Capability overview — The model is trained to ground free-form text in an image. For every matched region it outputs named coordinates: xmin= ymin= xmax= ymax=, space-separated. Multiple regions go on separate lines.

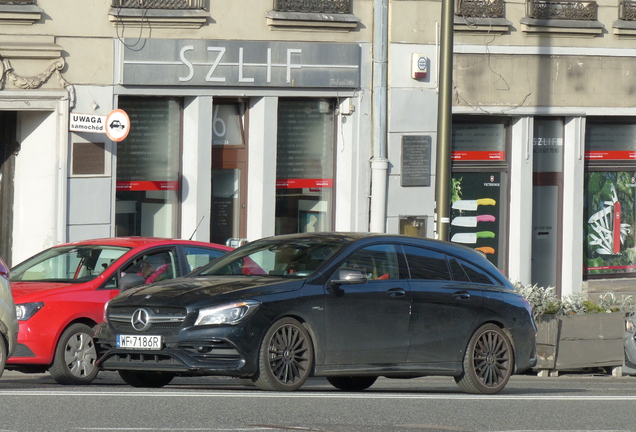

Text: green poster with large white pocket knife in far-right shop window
xmin=584 ymin=171 xmax=636 ymax=275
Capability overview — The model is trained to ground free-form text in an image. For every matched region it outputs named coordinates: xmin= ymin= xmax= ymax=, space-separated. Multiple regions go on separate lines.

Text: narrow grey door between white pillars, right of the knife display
xmin=532 ymin=118 xmax=563 ymax=294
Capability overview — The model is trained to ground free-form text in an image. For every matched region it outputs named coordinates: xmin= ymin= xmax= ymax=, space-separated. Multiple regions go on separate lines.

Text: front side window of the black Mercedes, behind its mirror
xmin=336 ymin=244 xmax=400 ymax=280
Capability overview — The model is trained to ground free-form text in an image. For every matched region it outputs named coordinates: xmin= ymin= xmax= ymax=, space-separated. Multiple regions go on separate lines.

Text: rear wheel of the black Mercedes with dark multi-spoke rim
xmin=455 ymin=324 xmax=514 ymax=394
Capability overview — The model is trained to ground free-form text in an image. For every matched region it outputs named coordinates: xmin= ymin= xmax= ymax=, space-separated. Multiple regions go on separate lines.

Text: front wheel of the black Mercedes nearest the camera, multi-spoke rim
xmin=254 ymin=318 xmax=314 ymax=391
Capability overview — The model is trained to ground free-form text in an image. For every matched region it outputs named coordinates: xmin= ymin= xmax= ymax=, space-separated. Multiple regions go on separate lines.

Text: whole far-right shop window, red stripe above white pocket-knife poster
xmin=583 ymin=118 xmax=636 ymax=278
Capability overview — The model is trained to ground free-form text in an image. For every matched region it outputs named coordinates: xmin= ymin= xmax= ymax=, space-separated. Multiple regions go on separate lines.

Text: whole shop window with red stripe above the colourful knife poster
xmin=449 ymin=118 xmax=508 ymax=270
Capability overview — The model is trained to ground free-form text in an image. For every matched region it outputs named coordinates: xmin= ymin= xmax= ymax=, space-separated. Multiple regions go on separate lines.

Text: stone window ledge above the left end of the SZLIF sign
xmin=109 ymin=8 xmax=210 ymax=29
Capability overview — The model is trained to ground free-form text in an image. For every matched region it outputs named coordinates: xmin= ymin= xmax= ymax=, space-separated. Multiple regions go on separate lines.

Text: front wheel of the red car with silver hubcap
xmin=49 ymin=323 xmax=99 ymax=385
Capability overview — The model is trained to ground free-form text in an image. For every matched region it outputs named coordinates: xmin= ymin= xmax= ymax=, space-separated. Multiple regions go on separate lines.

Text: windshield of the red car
xmin=11 ymin=245 xmax=130 ymax=283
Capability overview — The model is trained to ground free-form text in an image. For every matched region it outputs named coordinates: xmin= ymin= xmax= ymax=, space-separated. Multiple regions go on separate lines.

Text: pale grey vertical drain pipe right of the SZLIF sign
xmin=369 ymin=0 xmax=389 ymax=232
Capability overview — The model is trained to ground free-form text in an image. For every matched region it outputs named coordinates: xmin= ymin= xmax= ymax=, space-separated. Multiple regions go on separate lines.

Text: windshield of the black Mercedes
xmin=198 ymin=238 xmax=345 ymax=277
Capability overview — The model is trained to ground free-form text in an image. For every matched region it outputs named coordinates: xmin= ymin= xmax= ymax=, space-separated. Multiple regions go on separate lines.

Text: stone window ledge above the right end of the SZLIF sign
xmin=266 ymin=11 xmax=360 ymax=31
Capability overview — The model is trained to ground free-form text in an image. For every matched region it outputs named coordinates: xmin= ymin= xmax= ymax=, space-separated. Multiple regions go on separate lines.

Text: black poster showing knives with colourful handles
xmin=450 ymin=172 xmax=501 ymax=265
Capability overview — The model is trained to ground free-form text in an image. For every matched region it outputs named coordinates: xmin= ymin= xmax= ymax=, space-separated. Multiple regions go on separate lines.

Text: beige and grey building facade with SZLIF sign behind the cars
xmin=0 ymin=0 xmax=636 ymax=295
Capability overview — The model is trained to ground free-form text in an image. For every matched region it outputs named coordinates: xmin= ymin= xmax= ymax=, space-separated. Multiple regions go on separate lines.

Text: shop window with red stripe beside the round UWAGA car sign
xmin=115 ymin=97 xmax=181 ymax=237
